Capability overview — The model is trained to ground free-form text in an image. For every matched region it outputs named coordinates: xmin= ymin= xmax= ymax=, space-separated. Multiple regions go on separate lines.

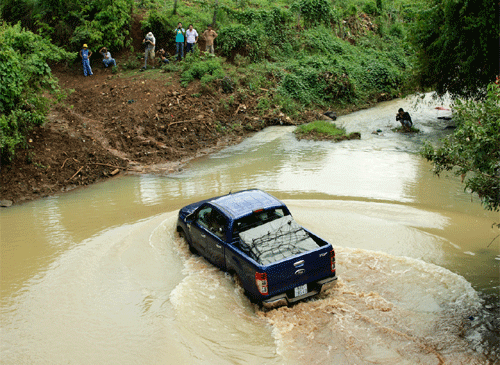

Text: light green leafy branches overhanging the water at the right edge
xmin=422 ymin=78 xmax=500 ymax=211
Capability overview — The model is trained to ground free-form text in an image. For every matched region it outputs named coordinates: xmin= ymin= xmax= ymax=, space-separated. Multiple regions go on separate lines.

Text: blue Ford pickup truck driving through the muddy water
xmin=177 ymin=189 xmax=337 ymax=308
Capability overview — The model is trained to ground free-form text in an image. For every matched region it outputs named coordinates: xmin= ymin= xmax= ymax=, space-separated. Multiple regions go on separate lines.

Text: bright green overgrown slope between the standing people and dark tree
xmin=142 ymin=0 xmax=419 ymax=115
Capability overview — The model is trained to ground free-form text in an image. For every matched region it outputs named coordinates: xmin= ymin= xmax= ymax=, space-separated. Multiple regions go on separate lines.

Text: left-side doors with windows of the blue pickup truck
xmin=191 ymin=206 xmax=228 ymax=269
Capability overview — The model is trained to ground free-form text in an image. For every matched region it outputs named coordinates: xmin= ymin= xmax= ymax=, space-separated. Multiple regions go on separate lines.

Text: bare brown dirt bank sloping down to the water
xmin=0 ymin=65 xmax=317 ymax=204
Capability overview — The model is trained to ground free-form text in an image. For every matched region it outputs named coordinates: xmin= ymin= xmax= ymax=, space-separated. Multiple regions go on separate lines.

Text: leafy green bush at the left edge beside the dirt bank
xmin=0 ymin=23 xmax=76 ymax=162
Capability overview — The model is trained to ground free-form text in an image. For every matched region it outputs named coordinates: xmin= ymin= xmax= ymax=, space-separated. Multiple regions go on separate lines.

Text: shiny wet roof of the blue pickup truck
xmin=210 ymin=189 xmax=283 ymax=219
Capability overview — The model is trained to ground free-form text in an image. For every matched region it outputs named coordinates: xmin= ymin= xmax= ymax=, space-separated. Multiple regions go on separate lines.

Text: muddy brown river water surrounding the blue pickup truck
xmin=0 ymin=94 xmax=500 ymax=364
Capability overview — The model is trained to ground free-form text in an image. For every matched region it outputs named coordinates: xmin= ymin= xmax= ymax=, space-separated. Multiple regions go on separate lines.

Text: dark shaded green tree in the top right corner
xmin=413 ymin=0 xmax=500 ymax=99
